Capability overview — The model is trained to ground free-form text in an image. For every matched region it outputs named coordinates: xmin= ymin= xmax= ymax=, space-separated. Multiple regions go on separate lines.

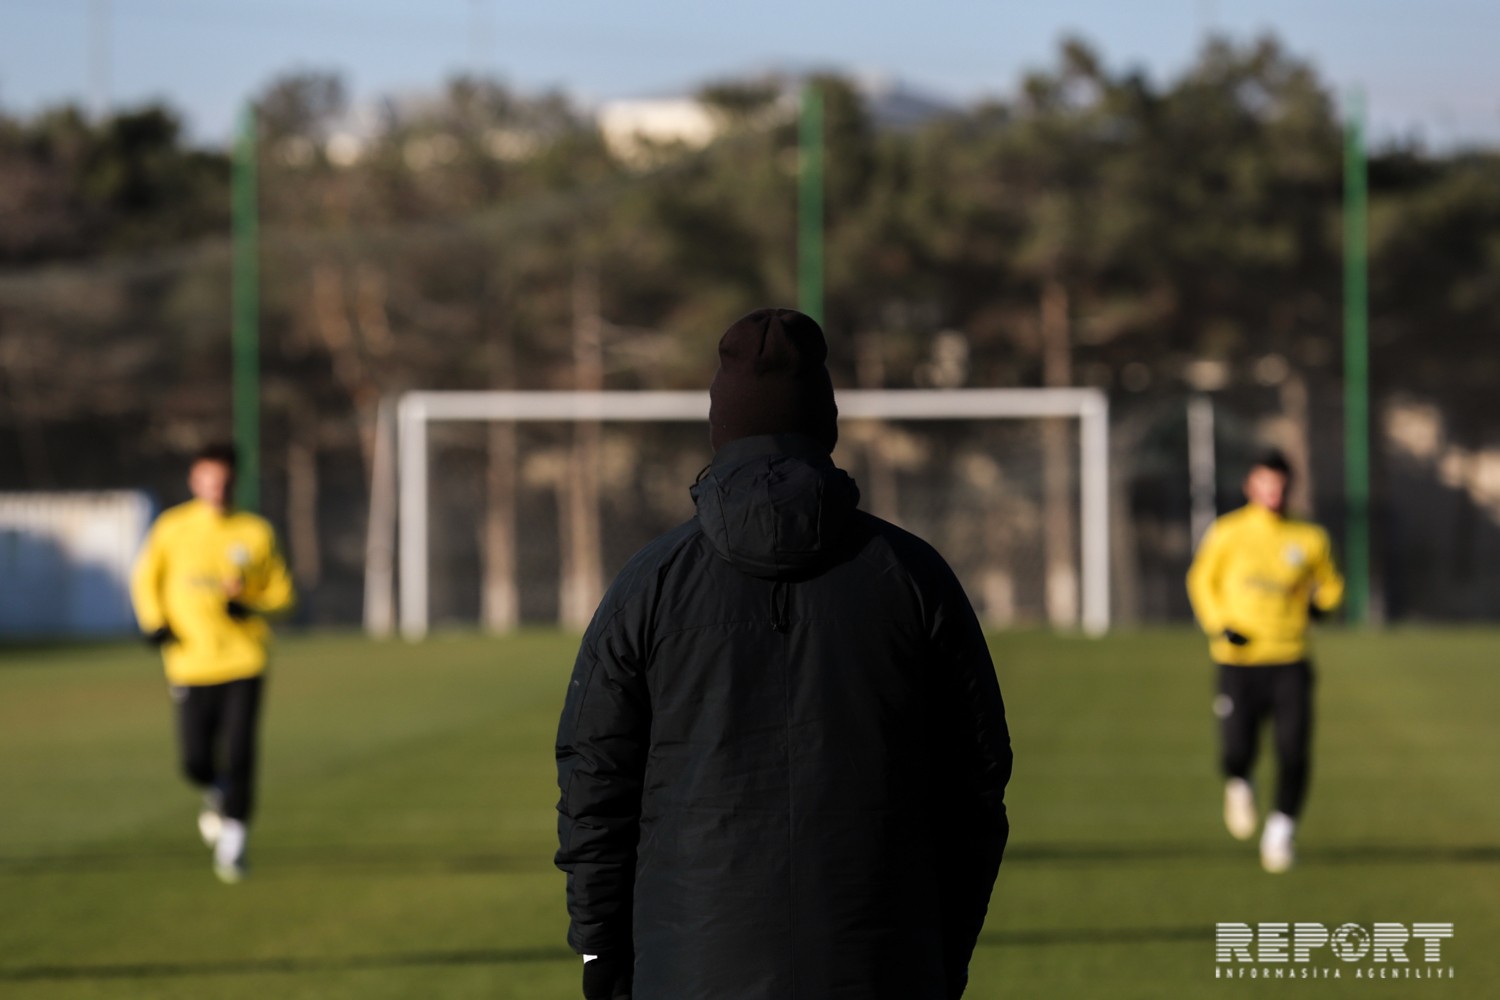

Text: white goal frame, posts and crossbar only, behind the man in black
xmin=393 ymin=388 xmax=1110 ymax=640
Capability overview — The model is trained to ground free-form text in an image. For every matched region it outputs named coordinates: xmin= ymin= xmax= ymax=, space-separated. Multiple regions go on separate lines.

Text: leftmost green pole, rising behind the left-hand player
xmin=231 ymin=105 xmax=261 ymax=510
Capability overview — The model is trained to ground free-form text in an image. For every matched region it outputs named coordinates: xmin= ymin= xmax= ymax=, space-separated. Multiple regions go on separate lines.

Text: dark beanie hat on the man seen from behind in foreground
xmin=708 ymin=309 xmax=839 ymax=451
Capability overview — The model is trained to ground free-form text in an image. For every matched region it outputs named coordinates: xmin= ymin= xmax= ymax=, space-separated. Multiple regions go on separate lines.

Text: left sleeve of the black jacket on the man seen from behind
xmin=557 ymin=597 xmax=651 ymax=955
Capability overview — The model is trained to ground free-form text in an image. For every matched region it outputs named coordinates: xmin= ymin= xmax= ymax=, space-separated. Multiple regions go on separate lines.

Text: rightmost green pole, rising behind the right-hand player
xmin=1344 ymin=88 xmax=1370 ymax=624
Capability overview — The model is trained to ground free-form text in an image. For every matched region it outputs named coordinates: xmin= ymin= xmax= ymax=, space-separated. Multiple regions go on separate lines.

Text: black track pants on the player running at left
xmin=173 ymin=678 xmax=264 ymax=823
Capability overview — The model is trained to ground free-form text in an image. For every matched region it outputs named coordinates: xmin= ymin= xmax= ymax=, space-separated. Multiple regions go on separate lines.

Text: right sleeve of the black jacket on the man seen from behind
xmin=932 ymin=565 xmax=1013 ymax=997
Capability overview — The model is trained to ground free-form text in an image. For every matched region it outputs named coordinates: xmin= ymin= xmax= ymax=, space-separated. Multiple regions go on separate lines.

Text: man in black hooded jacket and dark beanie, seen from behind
xmin=557 ymin=309 xmax=1011 ymax=1000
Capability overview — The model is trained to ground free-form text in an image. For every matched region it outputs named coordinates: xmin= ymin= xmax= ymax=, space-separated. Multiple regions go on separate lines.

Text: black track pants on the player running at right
xmin=1215 ymin=661 xmax=1313 ymax=817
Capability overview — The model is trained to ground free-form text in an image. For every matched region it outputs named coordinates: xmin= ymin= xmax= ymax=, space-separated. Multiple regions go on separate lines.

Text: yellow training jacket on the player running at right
xmin=1188 ymin=504 xmax=1344 ymax=666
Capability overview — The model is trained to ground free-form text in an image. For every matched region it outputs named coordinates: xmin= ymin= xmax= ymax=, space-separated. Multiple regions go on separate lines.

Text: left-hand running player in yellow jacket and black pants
xmin=131 ymin=445 xmax=296 ymax=882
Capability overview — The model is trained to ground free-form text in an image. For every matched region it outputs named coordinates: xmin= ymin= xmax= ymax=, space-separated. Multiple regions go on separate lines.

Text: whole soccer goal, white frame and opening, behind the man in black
xmin=381 ymin=388 xmax=1110 ymax=639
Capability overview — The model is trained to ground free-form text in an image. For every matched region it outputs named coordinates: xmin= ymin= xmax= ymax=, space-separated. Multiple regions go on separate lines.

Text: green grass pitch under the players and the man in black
xmin=0 ymin=631 xmax=1500 ymax=1000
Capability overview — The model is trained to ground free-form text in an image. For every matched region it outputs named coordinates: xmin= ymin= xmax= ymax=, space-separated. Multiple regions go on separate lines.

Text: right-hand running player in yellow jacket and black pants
xmin=1188 ymin=451 xmax=1344 ymax=871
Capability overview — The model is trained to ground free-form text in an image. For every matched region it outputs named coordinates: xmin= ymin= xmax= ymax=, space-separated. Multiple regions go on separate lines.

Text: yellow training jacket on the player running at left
xmin=131 ymin=501 xmax=296 ymax=684
